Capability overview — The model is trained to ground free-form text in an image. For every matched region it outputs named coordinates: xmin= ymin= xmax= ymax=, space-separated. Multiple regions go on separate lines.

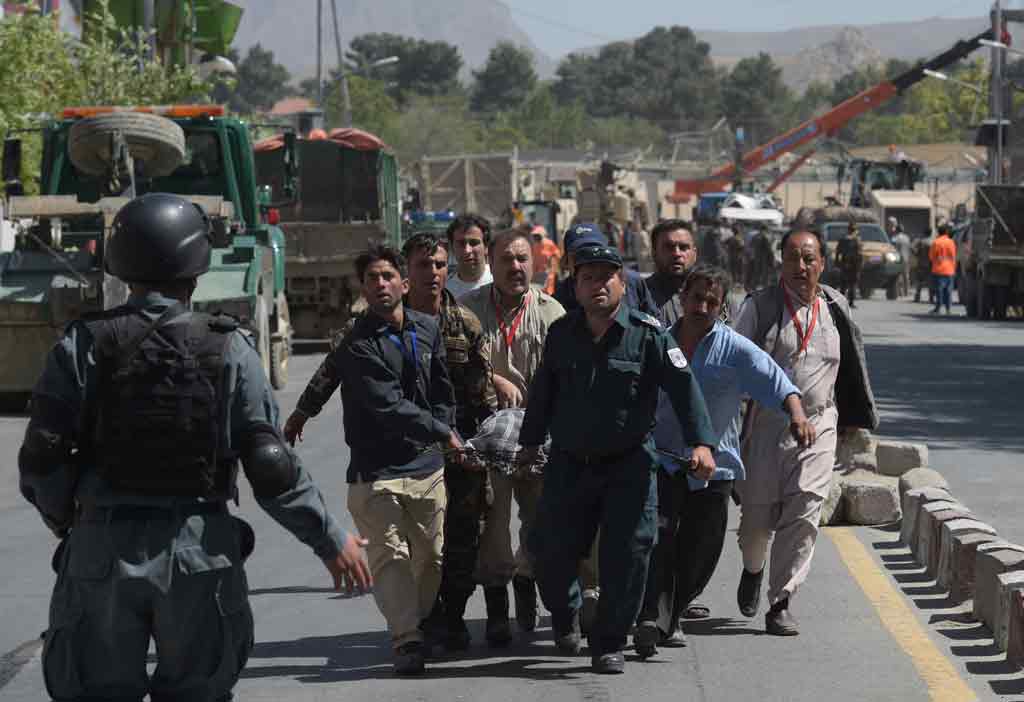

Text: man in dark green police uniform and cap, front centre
xmin=519 ymin=247 xmax=715 ymax=673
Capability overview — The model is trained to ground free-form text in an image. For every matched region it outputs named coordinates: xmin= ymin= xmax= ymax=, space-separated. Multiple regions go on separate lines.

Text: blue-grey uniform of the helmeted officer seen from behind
xmin=18 ymin=294 xmax=346 ymax=702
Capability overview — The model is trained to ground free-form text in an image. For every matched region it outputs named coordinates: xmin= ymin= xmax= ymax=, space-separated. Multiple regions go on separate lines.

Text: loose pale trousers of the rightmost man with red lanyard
xmin=738 ymin=492 xmax=824 ymax=605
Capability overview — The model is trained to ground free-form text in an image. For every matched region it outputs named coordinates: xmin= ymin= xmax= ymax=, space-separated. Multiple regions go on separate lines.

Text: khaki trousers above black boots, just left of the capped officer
xmin=476 ymin=471 xmax=543 ymax=587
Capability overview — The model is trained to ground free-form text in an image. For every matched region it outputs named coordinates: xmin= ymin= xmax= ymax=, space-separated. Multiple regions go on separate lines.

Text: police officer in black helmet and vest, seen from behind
xmin=18 ymin=193 xmax=371 ymax=702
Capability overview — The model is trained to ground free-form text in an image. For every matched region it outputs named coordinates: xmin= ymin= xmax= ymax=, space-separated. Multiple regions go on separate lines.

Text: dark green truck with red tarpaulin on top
xmin=256 ymin=129 xmax=401 ymax=341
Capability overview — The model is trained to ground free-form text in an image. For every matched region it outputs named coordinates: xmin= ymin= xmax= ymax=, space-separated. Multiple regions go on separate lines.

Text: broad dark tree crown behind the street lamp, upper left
xmin=346 ymin=33 xmax=462 ymax=104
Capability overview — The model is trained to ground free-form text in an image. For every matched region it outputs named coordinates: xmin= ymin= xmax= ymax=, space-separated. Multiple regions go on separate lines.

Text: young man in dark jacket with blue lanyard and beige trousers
xmin=332 ymin=246 xmax=462 ymax=675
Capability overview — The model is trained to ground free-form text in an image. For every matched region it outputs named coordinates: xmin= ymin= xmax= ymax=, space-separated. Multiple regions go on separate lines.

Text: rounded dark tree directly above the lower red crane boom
xmin=722 ymin=53 xmax=794 ymax=144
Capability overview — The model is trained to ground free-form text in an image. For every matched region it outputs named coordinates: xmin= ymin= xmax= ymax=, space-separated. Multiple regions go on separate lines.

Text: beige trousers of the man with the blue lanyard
xmin=348 ymin=470 xmax=447 ymax=648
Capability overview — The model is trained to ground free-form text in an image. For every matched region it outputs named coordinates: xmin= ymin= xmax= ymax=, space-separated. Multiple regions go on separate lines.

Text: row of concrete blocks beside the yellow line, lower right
xmin=899 ymin=468 xmax=1024 ymax=667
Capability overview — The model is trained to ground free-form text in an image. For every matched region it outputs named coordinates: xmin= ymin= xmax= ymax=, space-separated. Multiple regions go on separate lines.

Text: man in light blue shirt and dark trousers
xmin=634 ymin=265 xmax=814 ymax=658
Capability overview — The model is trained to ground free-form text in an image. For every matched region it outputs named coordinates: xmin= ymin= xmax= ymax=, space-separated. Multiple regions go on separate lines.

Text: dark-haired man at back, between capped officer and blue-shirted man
xmin=644 ymin=219 xmax=697 ymax=327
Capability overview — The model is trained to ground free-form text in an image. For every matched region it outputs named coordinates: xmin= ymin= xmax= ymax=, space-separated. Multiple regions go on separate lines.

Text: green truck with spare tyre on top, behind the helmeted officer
xmin=0 ymin=105 xmax=294 ymax=409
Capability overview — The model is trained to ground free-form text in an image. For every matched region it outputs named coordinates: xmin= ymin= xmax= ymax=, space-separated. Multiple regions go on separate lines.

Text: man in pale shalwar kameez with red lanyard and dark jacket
xmin=736 ymin=231 xmax=878 ymax=635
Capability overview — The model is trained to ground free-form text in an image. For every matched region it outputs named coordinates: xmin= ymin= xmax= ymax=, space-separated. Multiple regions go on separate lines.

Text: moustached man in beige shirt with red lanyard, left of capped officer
xmin=461 ymin=228 xmax=565 ymax=646
